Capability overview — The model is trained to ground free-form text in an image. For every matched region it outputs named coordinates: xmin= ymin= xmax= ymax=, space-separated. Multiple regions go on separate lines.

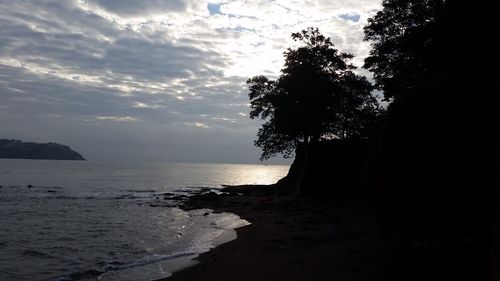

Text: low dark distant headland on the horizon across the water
xmin=0 ymin=139 xmax=85 ymax=160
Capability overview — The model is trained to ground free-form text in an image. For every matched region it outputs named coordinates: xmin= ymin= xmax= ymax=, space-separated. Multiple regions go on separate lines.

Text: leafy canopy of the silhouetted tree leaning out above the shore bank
xmin=247 ymin=28 xmax=378 ymax=159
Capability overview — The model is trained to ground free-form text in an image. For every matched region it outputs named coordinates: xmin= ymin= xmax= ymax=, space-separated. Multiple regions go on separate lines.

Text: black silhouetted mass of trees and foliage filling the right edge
xmin=365 ymin=0 xmax=500 ymax=280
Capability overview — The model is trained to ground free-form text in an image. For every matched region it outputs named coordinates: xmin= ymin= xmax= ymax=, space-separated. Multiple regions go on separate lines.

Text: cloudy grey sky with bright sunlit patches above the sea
xmin=0 ymin=0 xmax=381 ymax=163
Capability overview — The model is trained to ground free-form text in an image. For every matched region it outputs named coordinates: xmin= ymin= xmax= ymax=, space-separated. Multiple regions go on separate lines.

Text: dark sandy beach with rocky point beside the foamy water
xmin=157 ymin=186 xmax=397 ymax=281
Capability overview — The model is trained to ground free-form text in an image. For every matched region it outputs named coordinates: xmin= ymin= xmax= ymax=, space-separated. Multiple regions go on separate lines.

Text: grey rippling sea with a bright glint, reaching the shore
xmin=0 ymin=159 xmax=288 ymax=281
